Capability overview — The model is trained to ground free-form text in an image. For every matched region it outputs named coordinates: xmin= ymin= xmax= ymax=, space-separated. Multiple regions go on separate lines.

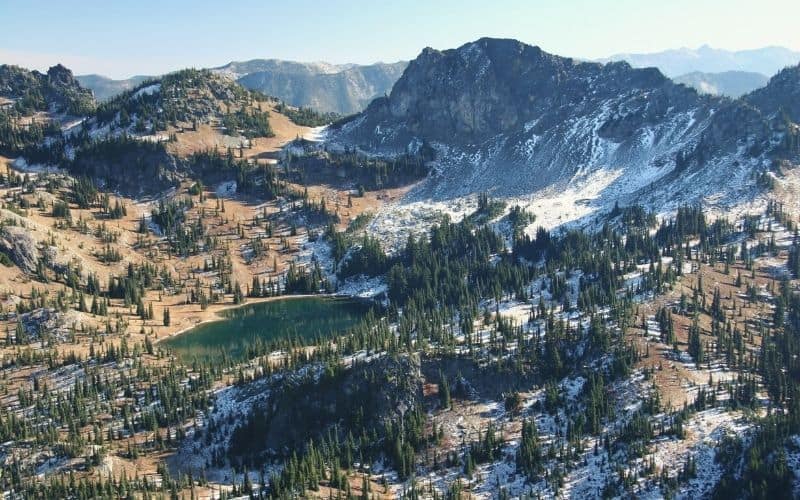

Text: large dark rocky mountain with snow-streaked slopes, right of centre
xmin=329 ymin=38 xmax=800 ymax=225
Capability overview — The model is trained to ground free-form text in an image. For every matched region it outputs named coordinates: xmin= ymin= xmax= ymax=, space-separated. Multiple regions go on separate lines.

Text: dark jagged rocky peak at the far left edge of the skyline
xmin=0 ymin=64 xmax=95 ymax=115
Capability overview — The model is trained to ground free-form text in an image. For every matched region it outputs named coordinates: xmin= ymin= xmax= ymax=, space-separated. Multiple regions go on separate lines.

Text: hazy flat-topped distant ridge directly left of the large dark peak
xmin=215 ymin=59 xmax=407 ymax=114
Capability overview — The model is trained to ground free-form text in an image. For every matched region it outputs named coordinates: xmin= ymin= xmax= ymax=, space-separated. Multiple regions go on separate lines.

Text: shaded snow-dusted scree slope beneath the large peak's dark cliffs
xmin=406 ymin=100 xmax=708 ymax=204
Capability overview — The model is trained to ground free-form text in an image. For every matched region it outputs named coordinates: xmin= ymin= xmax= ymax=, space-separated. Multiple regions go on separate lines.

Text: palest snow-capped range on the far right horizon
xmin=600 ymin=45 xmax=800 ymax=77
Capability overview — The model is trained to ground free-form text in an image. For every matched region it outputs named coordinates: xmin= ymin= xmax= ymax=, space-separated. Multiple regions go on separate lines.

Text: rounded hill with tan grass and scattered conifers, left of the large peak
xmin=5 ymin=69 xmax=340 ymax=196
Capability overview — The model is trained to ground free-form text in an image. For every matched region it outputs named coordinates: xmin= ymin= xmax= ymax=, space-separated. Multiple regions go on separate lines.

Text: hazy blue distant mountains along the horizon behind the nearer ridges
xmin=72 ymin=45 xmax=800 ymax=115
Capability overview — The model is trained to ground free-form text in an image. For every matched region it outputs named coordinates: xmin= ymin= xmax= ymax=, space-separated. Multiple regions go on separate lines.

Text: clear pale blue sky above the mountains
xmin=0 ymin=0 xmax=800 ymax=78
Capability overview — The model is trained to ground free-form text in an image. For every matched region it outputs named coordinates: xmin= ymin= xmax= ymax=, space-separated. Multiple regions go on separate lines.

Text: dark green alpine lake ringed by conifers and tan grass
xmin=162 ymin=297 xmax=374 ymax=362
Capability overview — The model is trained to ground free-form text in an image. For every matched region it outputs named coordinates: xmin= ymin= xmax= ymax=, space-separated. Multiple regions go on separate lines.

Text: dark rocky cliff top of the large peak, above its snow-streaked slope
xmin=344 ymin=38 xmax=698 ymax=148
